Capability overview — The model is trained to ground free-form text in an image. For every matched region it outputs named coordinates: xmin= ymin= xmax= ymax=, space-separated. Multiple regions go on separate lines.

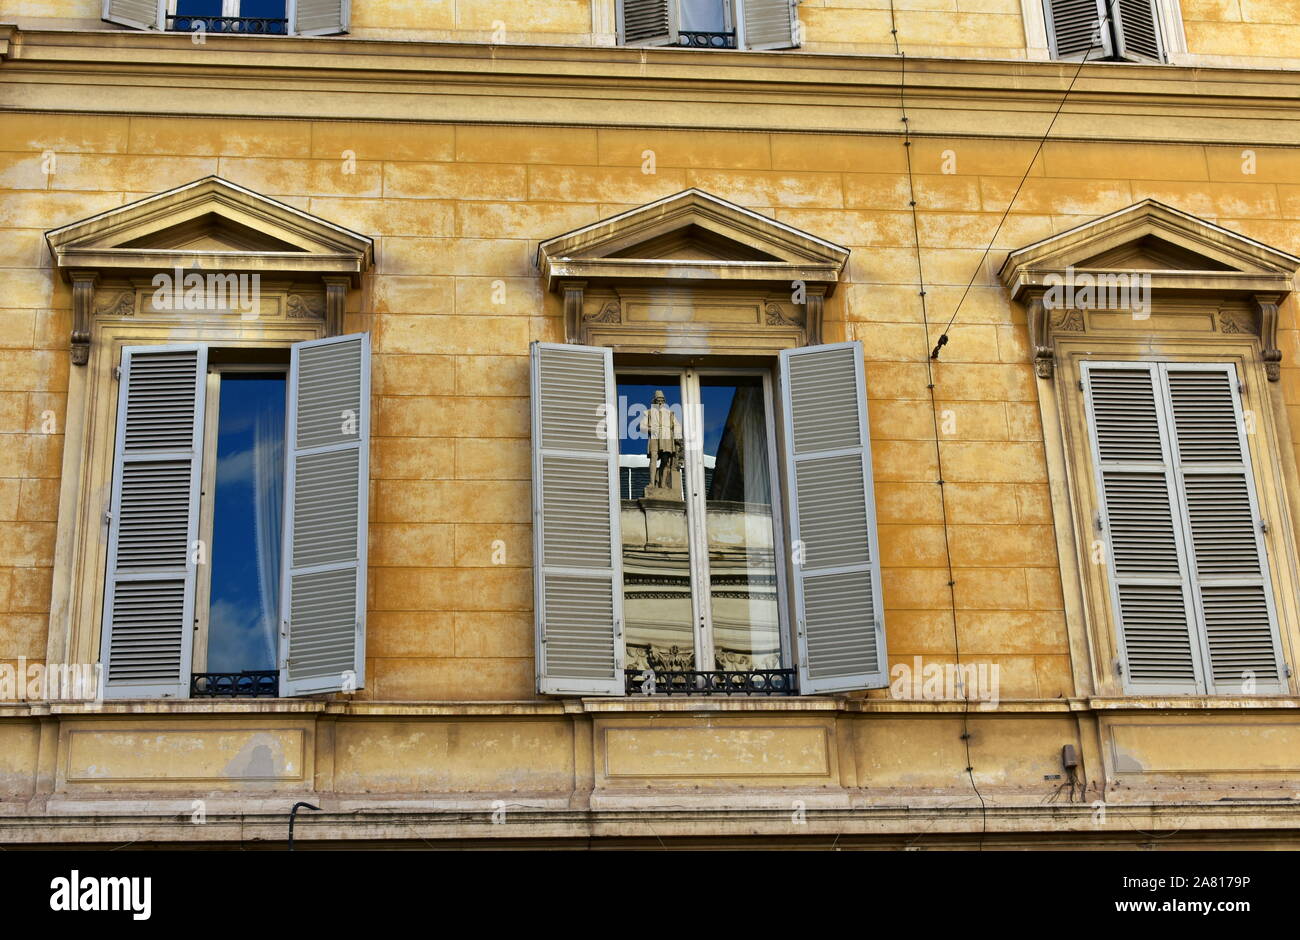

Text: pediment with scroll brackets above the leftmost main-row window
xmin=46 ymin=177 xmax=374 ymax=365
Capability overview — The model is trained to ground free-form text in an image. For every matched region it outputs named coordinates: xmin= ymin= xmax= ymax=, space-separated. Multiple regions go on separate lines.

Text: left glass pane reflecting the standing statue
xmin=619 ymin=374 xmax=696 ymax=671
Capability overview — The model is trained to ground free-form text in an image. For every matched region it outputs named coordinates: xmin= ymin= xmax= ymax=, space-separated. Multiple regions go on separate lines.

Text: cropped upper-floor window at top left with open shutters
xmin=103 ymin=0 xmax=351 ymax=36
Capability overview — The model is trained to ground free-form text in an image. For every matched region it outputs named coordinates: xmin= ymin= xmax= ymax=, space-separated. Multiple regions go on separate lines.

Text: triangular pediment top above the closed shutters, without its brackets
xmin=1001 ymin=199 xmax=1300 ymax=298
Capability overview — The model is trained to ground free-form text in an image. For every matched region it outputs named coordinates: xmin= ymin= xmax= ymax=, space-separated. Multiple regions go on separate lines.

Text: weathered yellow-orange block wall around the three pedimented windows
xmin=0 ymin=114 xmax=1300 ymax=701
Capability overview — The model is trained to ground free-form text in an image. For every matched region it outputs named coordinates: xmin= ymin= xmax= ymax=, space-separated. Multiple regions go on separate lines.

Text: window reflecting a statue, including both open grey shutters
xmin=532 ymin=343 xmax=887 ymax=694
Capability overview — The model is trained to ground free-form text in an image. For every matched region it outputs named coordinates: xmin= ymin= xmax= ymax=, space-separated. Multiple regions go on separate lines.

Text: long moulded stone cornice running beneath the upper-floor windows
xmin=10 ymin=27 xmax=1300 ymax=144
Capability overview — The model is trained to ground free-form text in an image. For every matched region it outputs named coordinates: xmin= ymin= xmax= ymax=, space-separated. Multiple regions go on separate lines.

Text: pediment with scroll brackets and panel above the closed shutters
xmin=1000 ymin=199 xmax=1300 ymax=381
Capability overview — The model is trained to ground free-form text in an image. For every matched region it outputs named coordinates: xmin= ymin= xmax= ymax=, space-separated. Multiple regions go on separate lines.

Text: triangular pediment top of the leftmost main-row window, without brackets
xmin=46 ymin=177 xmax=373 ymax=278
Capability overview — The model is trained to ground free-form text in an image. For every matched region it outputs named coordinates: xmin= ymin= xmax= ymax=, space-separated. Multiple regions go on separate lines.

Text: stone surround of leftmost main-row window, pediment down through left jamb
xmin=46 ymin=177 xmax=373 ymax=691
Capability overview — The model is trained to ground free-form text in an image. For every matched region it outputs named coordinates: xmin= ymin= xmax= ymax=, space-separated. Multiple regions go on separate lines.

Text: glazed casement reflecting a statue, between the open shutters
xmin=616 ymin=369 xmax=788 ymax=675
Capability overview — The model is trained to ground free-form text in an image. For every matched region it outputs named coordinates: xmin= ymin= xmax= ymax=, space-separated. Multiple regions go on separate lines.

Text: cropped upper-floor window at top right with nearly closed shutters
xmin=1044 ymin=0 xmax=1167 ymax=62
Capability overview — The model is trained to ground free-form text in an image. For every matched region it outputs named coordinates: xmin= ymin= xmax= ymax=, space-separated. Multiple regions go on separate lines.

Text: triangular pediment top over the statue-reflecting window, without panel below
xmin=538 ymin=190 xmax=849 ymax=293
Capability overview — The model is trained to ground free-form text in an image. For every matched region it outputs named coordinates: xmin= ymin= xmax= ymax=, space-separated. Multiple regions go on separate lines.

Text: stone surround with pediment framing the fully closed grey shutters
xmin=1000 ymin=199 xmax=1300 ymax=705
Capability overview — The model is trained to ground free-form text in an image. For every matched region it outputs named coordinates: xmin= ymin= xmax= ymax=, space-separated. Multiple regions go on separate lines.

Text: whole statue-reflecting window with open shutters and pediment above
xmin=532 ymin=191 xmax=887 ymax=696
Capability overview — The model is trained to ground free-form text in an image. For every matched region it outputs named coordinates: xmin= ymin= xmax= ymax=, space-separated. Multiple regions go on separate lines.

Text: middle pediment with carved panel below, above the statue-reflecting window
xmin=537 ymin=190 xmax=849 ymax=352
